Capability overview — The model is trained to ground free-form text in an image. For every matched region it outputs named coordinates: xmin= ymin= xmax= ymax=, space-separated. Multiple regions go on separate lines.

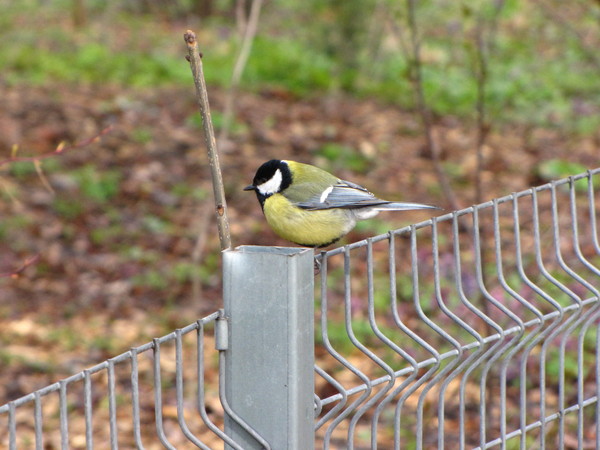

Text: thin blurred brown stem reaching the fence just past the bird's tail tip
xmin=407 ymin=0 xmax=460 ymax=210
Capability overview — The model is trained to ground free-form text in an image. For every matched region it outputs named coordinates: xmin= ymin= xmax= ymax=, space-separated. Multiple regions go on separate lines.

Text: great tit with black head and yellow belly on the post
xmin=244 ymin=159 xmax=439 ymax=247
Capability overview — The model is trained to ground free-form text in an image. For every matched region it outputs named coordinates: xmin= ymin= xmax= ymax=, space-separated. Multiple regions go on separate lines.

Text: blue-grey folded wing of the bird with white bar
xmin=295 ymin=180 xmax=390 ymax=210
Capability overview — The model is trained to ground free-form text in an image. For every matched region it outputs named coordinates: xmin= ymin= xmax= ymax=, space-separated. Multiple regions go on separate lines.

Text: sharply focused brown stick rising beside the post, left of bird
xmin=183 ymin=30 xmax=231 ymax=250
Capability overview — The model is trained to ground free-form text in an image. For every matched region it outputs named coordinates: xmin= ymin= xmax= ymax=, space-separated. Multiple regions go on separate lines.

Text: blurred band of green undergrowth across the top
xmin=0 ymin=0 xmax=600 ymax=134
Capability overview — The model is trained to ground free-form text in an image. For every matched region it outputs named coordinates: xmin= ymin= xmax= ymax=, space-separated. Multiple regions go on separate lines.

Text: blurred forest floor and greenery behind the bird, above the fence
xmin=0 ymin=0 xmax=600 ymax=442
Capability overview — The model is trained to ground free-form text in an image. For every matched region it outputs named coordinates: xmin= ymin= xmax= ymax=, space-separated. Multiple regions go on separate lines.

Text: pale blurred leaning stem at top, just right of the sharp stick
xmin=219 ymin=0 xmax=263 ymax=144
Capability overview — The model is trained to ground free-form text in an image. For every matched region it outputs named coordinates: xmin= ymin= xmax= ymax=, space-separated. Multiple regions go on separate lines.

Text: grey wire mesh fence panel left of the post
xmin=0 ymin=312 xmax=234 ymax=449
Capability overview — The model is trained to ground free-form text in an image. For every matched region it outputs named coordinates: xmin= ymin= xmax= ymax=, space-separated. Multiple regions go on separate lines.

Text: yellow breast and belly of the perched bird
xmin=264 ymin=194 xmax=355 ymax=247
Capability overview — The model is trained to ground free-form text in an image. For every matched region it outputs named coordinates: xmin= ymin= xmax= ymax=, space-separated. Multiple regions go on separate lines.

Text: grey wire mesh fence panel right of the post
xmin=315 ymin=169 xmax=600 ymax=449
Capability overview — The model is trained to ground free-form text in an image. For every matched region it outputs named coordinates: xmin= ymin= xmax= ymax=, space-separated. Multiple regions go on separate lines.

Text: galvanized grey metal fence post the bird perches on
xmin=223 ymin=246 xmax=314 ymax=450
